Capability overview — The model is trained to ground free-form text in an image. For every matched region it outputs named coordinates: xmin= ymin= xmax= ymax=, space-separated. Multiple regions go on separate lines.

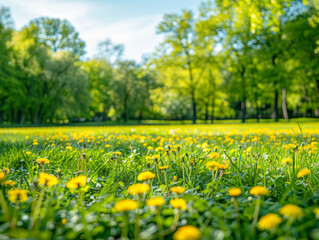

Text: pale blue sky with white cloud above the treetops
xmin=0 ymin=0 xmax=202 ymax=61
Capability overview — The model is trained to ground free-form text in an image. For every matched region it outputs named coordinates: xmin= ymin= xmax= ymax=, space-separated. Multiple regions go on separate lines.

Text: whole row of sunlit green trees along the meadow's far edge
xmin=0 ymin=0 xmax=319 ymax=124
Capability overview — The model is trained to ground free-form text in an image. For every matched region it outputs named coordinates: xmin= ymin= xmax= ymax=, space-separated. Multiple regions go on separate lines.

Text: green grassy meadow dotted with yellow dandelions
xmin=0 ymin=122 xmax=319 ymax=240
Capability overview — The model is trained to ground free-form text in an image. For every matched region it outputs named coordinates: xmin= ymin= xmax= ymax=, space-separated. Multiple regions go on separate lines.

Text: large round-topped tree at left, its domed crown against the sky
xmin=8 ymin=18 xmax=88 ymax=124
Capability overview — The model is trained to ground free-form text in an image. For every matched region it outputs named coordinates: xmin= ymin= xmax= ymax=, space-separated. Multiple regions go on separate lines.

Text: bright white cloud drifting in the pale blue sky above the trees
xmin=2 ymin=0 xmax=162 ymax=60
